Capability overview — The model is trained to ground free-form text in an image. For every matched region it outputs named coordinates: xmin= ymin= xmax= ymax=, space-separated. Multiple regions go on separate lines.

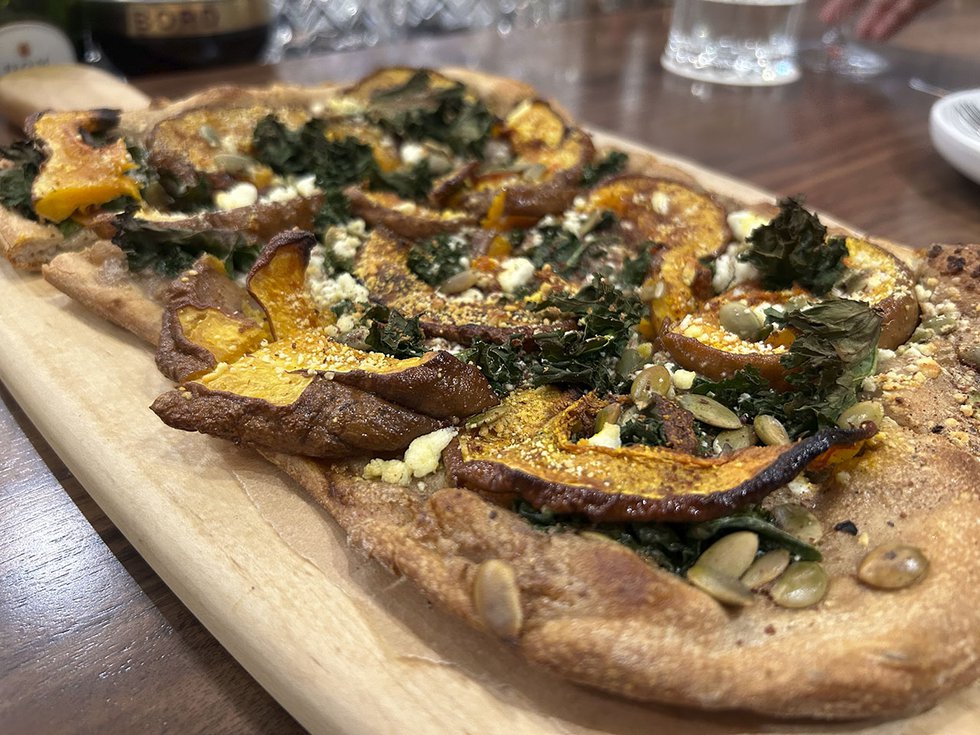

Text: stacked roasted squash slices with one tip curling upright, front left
xmin=152 ymin=232 xmax=498 ymax=458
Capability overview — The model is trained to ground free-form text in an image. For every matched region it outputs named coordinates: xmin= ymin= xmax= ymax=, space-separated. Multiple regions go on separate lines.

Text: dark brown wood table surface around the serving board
xmin=0 ymin=0 xmax=980 ymax=733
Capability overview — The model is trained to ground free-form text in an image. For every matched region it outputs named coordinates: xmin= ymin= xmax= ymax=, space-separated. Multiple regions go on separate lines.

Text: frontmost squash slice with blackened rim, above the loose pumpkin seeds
xmin=444 ymin=389 xmax=877 ymax=521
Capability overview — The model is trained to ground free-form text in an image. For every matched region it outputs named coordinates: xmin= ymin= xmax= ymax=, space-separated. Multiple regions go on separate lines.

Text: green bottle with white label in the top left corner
xmin=0 ymin=0 xmax=81 ymax=75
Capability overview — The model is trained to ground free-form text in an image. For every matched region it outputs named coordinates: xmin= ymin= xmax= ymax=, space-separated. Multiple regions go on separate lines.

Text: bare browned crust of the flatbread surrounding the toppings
xmin=0 ymin=70 xmax=980 ymax=719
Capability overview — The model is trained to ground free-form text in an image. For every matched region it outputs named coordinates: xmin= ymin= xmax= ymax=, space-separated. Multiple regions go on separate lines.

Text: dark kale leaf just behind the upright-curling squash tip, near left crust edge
xmin=112 ymin=214 xmax=260 ymax=277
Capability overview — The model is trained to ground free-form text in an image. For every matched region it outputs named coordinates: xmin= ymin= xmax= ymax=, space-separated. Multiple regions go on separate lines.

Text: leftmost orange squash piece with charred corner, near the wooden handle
xmin=28 ymin=110 xmax=140 ymax=222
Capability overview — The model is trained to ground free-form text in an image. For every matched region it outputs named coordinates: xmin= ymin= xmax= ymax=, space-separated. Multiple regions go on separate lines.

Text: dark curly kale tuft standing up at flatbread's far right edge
xmin=740 ymin=198 xmax=847 ymax=296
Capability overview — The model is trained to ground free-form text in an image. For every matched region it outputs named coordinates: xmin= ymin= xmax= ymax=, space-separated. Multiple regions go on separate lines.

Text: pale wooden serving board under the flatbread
xmin=0 ymin=136 xmax=980 ymax=735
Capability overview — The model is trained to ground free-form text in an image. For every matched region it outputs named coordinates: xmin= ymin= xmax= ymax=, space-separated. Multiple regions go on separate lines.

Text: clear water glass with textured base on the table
xmin=660 ymin=0 xmax=805 ymax=86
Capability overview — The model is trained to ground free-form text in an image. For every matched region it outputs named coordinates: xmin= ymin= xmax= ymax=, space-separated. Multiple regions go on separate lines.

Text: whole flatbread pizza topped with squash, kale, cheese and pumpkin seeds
xmin=0 ymin=68 xmax=980 ymax=719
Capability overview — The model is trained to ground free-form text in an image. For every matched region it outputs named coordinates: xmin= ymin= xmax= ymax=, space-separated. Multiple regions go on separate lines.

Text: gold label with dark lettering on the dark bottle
xmin=104 ymin=0 xmax=269 ymax=38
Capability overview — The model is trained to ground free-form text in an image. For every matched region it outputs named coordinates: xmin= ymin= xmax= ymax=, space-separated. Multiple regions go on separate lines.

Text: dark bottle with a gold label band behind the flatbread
xmin=81 ymin=0 xmax=271 ymax=76
